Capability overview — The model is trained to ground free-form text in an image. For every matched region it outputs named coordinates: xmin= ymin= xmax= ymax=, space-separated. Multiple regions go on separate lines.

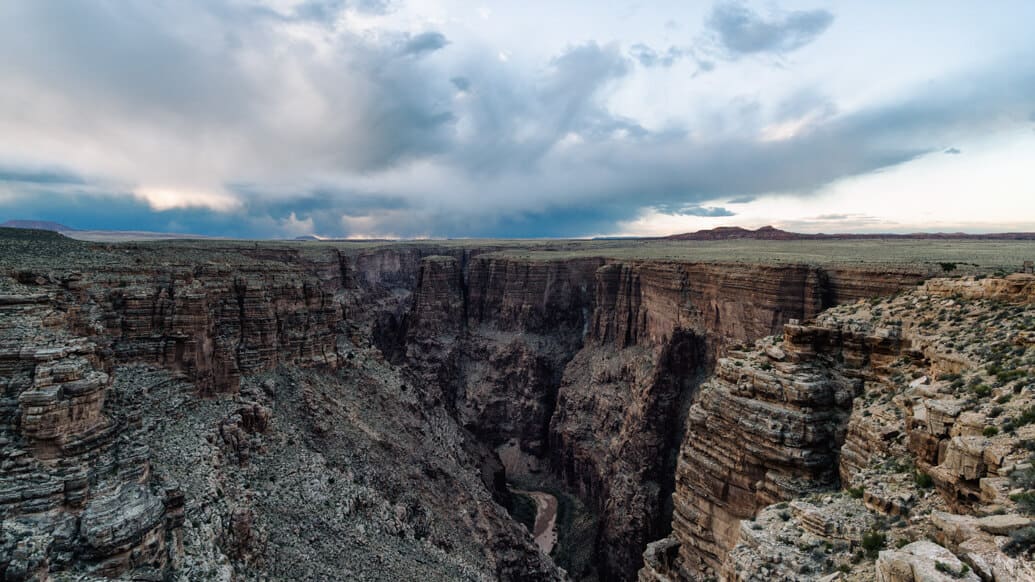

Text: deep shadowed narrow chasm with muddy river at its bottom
xmin=373 ymin=251 xmax=714 ymax=581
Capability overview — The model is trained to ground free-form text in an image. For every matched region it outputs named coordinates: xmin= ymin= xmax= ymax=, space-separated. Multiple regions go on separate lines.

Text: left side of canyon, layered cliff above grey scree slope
xmin=0 ymin=241 xmax=562 ymax=580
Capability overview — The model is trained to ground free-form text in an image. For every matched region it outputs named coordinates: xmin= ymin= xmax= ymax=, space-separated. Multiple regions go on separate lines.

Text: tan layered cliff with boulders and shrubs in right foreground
xmin=640 ymin=275 xmax=1035 ymax=582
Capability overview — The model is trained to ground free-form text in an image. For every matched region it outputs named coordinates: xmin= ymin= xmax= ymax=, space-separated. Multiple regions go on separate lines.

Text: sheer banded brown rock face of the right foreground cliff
xmin=658 ymin=324 xmax=899 ymax=577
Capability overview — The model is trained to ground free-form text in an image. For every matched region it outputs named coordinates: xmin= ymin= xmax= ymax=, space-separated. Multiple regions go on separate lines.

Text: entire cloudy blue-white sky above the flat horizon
xmin=0 ymin=0 xmax=1035 ymax=238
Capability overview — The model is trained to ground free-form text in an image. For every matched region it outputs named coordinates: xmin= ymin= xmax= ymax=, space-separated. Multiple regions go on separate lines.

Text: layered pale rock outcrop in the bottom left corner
xmin=0 ymin=294 xmax=183 ymax=580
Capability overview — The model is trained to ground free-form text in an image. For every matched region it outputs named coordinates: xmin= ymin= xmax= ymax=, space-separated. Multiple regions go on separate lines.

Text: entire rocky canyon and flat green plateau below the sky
xmin=0 ymin=229 xmax=1035 ymax=582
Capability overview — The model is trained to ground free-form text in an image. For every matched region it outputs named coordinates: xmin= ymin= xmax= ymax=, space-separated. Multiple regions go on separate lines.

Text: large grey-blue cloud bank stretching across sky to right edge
xmin=0 ymin=0 xmax=1035 ymax=237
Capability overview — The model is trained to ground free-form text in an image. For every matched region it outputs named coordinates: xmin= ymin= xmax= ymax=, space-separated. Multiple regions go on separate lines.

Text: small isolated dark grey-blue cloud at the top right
xmin=706 ymin=1 xmax=834 ymax=58
